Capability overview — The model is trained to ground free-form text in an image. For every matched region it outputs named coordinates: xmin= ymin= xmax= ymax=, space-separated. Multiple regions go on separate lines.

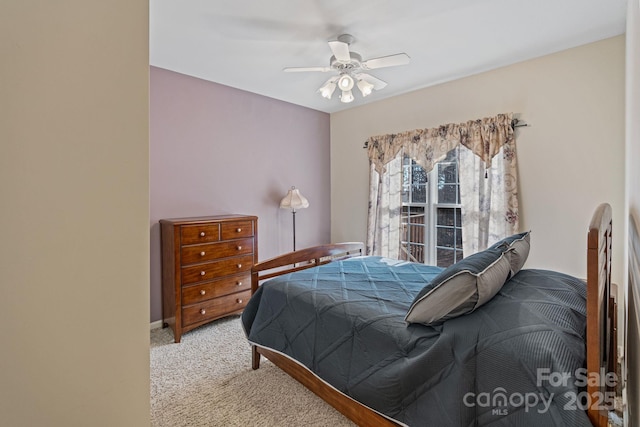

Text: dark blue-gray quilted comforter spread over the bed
xmin=242 ymin=257 xmax=591 ymax=426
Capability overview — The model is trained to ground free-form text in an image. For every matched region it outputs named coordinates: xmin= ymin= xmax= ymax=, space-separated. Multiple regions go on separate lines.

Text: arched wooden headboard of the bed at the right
xmin=587 ymin=203 xmax=617 ymax=427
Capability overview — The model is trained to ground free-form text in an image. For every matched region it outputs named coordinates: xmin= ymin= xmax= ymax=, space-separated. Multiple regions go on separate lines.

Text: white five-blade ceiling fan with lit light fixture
xmin=284 ymin=34 xmax=410 ymax=102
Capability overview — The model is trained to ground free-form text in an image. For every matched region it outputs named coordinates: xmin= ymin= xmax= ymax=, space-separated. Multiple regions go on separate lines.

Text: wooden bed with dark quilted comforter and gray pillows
xmin=241 ymin=204 xmax=616 ymax=426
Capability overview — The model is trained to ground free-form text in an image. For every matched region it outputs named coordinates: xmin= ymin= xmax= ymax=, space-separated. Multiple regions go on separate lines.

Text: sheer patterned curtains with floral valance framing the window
xmin=367 ymin=113 xmax=519 ymax=258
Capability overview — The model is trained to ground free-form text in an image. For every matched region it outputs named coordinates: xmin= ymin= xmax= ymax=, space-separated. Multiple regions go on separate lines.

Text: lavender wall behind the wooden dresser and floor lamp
xmin=150 ymin=67 xmax=331 ymax=322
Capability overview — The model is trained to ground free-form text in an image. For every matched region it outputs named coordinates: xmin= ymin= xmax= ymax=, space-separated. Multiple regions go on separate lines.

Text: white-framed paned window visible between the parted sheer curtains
xmin=400 ymin=148 xmax=463 ymax=267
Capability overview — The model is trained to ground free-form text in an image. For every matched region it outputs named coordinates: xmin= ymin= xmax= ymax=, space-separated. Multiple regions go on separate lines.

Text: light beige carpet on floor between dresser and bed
xmin=150 ymin=316 xmax=355 ymax=427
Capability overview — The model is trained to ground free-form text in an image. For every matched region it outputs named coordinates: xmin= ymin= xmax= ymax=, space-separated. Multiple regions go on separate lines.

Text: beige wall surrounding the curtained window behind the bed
xmin=331 ymin=36 xmax=625 ymax=283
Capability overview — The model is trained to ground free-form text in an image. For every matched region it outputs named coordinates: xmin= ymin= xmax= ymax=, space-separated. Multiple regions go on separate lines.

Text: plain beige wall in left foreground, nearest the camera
xmin=0 ymin=0 xmax=149 ymax=427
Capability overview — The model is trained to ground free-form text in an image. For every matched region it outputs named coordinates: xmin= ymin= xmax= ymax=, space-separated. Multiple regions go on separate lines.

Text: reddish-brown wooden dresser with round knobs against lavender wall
xmin=160 ymin=215 xmax=258 ymax=343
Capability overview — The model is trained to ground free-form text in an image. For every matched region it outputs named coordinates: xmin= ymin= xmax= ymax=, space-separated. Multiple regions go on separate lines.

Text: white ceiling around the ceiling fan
xmin=149 ymin=0 xmax=627 ymax=113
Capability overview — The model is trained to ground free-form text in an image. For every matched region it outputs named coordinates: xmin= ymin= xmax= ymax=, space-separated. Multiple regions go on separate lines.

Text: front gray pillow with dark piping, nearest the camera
xmin=405 ymin=247 xmax=511 ymax=325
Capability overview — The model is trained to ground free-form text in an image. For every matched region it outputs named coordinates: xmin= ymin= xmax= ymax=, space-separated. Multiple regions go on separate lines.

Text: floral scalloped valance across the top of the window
xmin=366 ymin=113 xmax=513 ymax=173
